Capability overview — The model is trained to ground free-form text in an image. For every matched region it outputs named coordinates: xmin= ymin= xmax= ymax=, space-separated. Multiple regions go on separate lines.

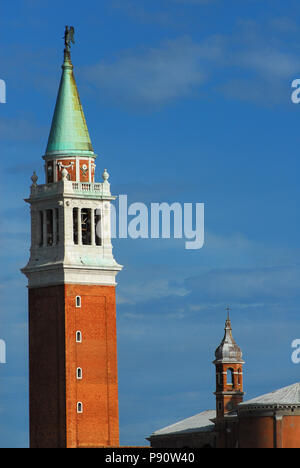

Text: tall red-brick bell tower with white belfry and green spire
xmin=22 ymin=27 xmax=122 ymax=448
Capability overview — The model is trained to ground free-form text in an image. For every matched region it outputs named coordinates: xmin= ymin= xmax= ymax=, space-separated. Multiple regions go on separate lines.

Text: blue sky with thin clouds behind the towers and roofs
xmin=0 ymin=0 xmax=300 ymax=447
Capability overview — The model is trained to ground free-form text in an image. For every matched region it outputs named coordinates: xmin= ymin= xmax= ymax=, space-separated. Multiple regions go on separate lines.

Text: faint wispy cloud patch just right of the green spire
xmin=85 ymin=37 xmax=221 ymax=106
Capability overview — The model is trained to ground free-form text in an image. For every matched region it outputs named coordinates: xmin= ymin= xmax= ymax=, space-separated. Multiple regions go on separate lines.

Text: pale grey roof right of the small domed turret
xmin=239 ymin=383 xmax=300 ymax=408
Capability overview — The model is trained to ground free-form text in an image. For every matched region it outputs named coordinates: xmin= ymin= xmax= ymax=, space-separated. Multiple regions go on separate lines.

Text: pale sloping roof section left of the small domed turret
xmin=150 ymin=410 xmax=216 ymax=437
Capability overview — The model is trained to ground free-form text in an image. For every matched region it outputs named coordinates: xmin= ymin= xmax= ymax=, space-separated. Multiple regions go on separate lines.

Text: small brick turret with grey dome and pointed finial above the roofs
xmin=214 ymin=308 xmax=245 ymax=421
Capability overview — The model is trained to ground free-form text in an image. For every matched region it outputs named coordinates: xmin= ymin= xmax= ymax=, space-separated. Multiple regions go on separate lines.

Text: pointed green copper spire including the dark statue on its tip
xmin=46 ymin=27 xmax=94 ymax=156
